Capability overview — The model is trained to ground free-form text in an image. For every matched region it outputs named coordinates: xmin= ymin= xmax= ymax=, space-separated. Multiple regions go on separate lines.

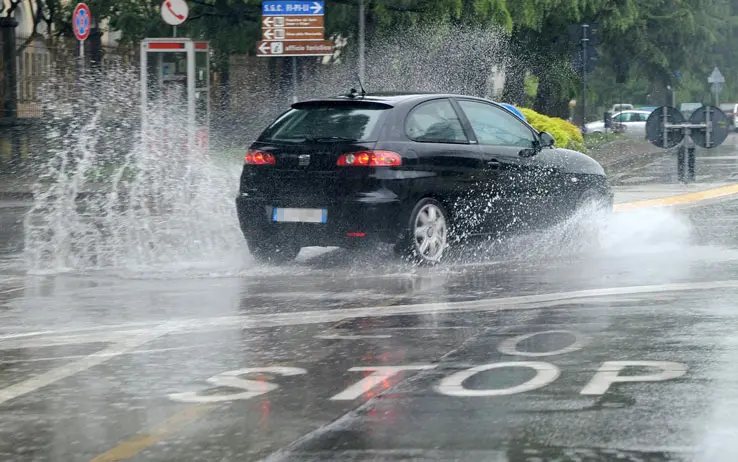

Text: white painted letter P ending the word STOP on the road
xmin=579 ymin=361 xmax=687 ymax=395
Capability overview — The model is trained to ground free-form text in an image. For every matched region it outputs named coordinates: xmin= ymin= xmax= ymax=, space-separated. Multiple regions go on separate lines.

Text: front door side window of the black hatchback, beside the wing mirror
xmin=459 ymin=100 xmax=535 ymax=148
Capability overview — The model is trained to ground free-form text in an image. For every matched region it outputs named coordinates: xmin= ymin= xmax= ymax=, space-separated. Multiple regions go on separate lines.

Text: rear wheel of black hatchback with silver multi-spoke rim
xmin=395 ymin=197 xmax=450 ymax=265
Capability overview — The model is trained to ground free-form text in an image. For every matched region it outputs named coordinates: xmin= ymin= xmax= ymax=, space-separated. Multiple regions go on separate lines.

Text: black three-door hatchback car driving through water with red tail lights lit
xmin=236 ymin=92 xmax=613 ymax=263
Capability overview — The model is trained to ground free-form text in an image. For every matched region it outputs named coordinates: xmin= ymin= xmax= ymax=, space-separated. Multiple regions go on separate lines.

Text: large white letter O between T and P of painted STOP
xmin=435 ymin=361 xmax=561 ymax=397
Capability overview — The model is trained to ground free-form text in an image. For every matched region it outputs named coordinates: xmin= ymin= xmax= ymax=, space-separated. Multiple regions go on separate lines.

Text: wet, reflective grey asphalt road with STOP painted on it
xmin=0 ymin=147 xmax=738 ymax=462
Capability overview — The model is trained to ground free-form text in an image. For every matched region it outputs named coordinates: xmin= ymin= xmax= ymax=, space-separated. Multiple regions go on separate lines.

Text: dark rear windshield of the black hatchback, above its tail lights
xmin=259 ymin=102 xmax=392 ymax=142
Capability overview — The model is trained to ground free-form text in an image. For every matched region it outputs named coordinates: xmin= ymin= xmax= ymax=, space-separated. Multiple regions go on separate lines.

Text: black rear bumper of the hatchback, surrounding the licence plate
xmin=236 ymin=194 xmax=404 ymax=247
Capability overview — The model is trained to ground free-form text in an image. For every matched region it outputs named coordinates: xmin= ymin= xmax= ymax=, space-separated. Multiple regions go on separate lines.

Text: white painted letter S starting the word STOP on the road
xmin=168 ymin=366 xmax=307 ymax=403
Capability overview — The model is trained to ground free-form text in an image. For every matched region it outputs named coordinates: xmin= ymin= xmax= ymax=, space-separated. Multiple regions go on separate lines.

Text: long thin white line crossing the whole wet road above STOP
xmin=0 ymin=280 xmax=738 ymax=351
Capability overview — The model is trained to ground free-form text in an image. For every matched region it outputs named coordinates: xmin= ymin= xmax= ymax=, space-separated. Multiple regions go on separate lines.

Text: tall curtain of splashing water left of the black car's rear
xmin=25 ymin=69 xmax=243 ymax=272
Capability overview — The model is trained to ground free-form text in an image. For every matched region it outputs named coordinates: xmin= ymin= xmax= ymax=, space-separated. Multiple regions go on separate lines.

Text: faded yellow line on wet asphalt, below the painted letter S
xmin=90 ymin=404 xmax=217 ymax=462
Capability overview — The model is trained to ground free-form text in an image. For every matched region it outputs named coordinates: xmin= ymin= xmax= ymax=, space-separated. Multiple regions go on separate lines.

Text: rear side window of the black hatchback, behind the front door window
xmin=405 ymin=99 xmax=468 ymax=143
